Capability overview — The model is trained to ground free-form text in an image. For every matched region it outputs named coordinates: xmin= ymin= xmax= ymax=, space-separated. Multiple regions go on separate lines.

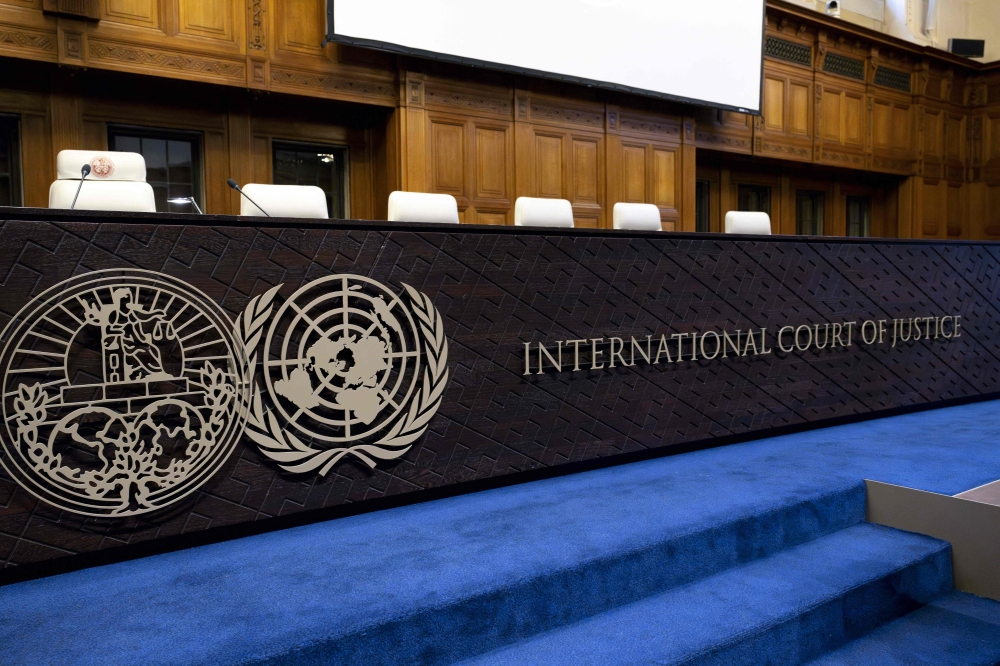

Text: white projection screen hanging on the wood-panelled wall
xmin=327 ymin=0 xmax=765 ymax=113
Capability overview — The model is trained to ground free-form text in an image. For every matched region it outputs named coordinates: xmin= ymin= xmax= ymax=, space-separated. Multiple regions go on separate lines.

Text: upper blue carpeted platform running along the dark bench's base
xmin=0 ymin=402 xmax=1000 ymax=664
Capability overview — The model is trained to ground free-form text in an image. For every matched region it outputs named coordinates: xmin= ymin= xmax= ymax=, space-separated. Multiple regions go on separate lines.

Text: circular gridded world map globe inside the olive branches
xmin=265 ymin=275 xmax=420 ymax=444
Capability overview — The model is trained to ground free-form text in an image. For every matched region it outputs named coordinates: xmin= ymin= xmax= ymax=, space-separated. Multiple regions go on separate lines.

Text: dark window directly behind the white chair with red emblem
xmin=108 ymin=125 xmax=205 ymax=213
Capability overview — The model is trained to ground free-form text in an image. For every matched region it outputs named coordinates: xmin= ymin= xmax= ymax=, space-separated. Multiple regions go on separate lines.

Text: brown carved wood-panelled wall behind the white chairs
xmin=0 ymin=0 xmax=1000 ymax=239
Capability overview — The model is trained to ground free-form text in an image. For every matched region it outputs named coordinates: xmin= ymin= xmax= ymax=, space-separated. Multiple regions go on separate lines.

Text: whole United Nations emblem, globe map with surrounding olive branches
xmin=238 ymin=275 xmax=448 ymax=475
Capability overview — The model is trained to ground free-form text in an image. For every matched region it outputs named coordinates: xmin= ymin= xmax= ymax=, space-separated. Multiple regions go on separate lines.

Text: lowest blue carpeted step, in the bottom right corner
xmin=809 ymin=592 xmax=1000 ymax=666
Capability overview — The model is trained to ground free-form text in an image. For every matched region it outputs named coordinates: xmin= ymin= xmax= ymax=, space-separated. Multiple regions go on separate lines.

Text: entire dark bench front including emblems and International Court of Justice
xmin=0 ymin=216 xmax=1000 ymax=575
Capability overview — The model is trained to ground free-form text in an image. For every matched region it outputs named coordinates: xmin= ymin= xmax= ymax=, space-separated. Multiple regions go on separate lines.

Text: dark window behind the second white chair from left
xmin=273 ymin=142 xmax=347 ymax=220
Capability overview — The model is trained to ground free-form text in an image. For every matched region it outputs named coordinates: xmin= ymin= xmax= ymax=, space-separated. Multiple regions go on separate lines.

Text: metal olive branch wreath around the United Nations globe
xmin=234 ymin=284 xmax=448 ymax=476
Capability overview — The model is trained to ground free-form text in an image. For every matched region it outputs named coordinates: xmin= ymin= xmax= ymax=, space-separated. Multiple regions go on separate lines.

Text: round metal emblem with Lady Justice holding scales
xmin=0 ymin=270 xmax=251 ymax=517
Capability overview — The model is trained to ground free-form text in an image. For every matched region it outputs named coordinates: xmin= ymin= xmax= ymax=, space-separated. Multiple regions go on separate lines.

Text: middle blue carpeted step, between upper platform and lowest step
xmin=454 ymin=524 xmax=951 ymax=666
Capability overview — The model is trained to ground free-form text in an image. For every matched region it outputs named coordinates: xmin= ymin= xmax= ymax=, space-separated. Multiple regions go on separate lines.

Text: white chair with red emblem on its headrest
xmin=49 ymin=150 xmax=156 ymax=213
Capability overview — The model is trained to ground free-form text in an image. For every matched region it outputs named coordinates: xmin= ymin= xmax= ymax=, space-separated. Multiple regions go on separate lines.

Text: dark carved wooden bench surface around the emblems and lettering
xmin=0 ymin=215 xmax=1000 ymax=568
